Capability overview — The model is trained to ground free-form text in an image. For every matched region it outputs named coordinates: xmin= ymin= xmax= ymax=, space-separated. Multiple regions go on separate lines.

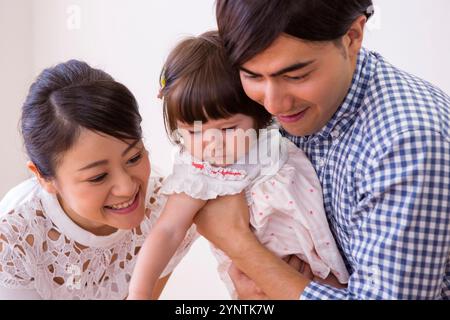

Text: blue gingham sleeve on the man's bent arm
xmin=300 ymin=131 xmax=450 ymax=300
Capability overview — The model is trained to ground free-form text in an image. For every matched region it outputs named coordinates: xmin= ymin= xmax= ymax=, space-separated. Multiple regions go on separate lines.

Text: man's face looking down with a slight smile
xmin=240 ymin=34 xmax=356 ymax=136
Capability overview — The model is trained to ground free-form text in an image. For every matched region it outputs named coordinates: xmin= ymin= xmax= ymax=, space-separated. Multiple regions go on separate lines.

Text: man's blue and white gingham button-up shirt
xmin=282 ymin=49 xmax=450 ymax=299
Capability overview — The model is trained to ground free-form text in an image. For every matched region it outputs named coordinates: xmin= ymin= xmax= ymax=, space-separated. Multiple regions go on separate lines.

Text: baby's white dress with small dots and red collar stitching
xmin=161 ymin=129 xmax=349 ymax=298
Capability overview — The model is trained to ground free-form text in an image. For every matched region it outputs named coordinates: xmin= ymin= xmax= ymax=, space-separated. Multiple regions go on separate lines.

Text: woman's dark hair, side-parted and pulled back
xmin=21 ymin=60 xmax=142 ymax=179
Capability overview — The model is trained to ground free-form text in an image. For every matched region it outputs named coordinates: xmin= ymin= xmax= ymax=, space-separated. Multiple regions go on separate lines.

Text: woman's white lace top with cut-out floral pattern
xmin=0 ymin=179 xmax=196 ymax=299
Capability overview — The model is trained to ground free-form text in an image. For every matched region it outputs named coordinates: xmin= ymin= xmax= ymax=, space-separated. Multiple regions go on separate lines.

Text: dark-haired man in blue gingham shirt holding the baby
xmin=196 ymin=0 xmax=450 ymax=299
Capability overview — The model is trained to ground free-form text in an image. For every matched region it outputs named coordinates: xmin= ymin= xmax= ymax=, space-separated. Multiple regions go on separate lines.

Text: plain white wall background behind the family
xmin=0 ymin=0 xmax=450 ymax=299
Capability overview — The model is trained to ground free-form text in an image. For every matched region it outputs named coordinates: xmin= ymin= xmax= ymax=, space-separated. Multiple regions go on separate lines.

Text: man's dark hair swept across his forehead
xmin=216 ymin=0 xmax=373 ymax=66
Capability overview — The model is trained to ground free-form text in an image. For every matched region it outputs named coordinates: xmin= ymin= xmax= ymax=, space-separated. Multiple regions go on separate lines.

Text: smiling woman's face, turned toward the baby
xmin=47 ymin=129 xmax=150 ymax=235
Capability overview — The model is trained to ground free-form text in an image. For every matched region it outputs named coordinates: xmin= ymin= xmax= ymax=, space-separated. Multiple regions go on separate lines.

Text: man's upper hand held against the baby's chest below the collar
xmin=194 ymin=193 xmax=253 ymax=253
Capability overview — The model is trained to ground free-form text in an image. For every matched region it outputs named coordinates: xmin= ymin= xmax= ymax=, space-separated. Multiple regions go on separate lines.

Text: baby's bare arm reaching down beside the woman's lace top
xmin=128 ymin=193 xmax=206 ymax=299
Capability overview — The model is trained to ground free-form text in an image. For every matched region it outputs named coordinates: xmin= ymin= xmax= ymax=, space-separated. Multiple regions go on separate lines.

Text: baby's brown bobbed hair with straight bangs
xmin=161 ymin=31 xmax=272 ymax=143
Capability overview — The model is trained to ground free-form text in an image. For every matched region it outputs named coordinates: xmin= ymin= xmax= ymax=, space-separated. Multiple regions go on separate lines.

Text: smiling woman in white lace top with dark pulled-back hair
xmin=0 ymin=60 xmax=196 ymax=299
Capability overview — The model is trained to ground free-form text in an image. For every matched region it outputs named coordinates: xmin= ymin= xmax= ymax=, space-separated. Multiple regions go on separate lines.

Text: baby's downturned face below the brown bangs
xmin=178 ymin=114 xmax=257 ymax=166
